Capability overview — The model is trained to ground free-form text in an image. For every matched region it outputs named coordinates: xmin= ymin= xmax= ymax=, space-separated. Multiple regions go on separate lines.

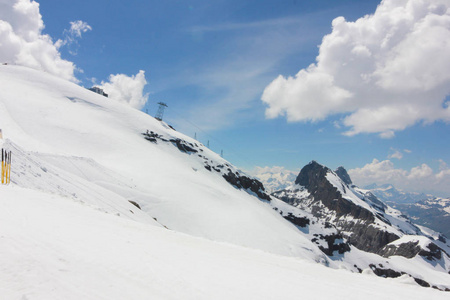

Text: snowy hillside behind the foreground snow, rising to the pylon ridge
xmin=0 ymin=65 xmax=326 ymax=261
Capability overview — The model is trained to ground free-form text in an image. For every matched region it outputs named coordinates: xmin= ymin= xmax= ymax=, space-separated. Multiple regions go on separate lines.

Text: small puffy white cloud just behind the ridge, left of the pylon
xmin=100 ymin=70 xmax=148 ymax=109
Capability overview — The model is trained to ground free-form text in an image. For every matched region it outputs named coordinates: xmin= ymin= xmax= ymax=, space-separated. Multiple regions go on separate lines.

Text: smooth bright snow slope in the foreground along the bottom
xmin=0 ymin=185 xmax=448 ymax=300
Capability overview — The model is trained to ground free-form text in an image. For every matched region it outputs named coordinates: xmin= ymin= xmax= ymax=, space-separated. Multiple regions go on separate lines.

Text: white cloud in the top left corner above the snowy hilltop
xmin=0 ymin=0 xmax=78 ymax=82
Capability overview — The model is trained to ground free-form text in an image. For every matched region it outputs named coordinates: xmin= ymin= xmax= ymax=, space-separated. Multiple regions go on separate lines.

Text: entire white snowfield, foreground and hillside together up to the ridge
xmin=0 ymin=65 xmax=448 ymax=300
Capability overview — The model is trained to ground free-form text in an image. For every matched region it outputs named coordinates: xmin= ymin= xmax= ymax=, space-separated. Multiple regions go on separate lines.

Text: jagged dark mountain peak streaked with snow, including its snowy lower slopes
xmin=273 ymin=161 xmax=450 ymax=289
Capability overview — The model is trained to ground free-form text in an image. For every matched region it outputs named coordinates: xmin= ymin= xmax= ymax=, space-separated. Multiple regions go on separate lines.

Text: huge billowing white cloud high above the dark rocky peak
xmin=261 ymin=0 xmax=450 ymax=138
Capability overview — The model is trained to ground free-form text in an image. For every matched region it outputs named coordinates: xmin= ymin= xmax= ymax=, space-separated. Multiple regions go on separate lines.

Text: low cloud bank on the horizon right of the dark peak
xmin=348 ymin=159 xmax=450 ymax=196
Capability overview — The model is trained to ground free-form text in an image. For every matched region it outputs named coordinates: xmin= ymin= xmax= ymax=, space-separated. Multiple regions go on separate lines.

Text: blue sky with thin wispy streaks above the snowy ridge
xmin=3 ymin=0 xmax=450 ymax=196
